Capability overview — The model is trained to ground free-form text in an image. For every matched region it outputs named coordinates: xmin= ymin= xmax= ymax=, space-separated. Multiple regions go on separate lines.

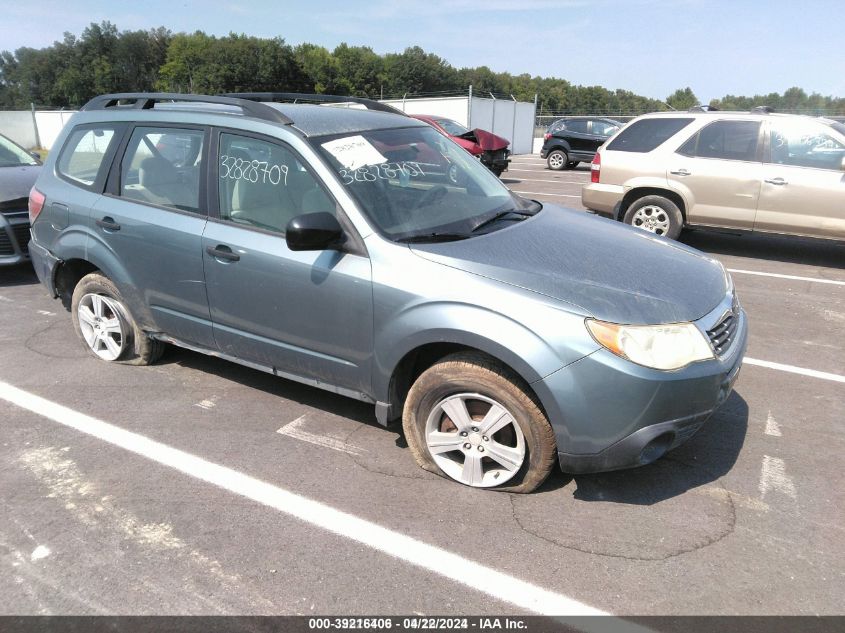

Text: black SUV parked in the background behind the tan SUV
xmin=540 ymin=116 xmax=624 ymax=171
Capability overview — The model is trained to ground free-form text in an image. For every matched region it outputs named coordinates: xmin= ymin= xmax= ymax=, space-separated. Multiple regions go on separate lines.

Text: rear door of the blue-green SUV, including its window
xmin=90 ymin=125 xmax=214 ymax=348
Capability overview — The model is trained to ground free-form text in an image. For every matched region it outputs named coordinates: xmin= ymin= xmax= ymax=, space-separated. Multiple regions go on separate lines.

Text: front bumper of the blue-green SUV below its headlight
xmin=533 ymin=308 xmax=748 ymax=473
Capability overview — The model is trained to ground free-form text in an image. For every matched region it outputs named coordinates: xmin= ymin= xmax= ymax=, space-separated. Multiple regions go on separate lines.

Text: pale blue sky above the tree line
xmin=0 ymin=0 xmax=845 ymax=103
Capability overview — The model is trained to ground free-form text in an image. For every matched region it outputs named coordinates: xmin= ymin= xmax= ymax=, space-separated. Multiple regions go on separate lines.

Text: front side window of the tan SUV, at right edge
xmin=769 ymin=121 xmax=845 ymax=170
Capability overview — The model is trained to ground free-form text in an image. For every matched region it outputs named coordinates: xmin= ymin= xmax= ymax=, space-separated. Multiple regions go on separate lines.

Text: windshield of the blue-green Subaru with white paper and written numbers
xmin=312 ymin=126 xmax=538 ymax=241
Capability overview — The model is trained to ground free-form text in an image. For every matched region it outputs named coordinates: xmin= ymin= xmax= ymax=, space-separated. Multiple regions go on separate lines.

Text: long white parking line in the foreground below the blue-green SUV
xmin=0 ymin=381 xmax=607 ymax=624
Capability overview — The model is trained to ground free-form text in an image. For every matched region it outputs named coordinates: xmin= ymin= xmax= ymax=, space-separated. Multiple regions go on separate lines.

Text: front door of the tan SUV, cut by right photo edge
xmin=754 ymin=119 xmax=845 ymax=239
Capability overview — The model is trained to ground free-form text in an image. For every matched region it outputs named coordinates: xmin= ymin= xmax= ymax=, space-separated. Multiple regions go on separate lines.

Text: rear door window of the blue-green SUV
xmin=120 ymin=127 xmax=205 ymax=211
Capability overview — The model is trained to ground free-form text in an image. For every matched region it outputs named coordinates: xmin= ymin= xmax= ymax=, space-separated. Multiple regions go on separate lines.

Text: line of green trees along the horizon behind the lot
xmin=0 ymin=22 xmax=845 ymax=115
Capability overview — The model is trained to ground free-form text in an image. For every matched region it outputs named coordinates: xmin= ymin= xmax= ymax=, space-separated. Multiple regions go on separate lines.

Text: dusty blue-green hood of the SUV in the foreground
xmin=412 ymin=205 xmax=728 ymax=324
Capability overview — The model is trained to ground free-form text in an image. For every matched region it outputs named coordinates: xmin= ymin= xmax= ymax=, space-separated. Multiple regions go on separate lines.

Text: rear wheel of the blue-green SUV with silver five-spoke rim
xmin=71 ymin=273 xmax=164 ymax=365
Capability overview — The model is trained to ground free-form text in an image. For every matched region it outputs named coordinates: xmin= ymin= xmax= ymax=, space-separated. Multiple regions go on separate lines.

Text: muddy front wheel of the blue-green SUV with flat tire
xmin=402 ymin=353 xmax=557 ymax=492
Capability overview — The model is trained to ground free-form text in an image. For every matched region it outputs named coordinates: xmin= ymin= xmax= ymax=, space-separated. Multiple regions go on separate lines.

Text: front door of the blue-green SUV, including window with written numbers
xmin=203 ymin=131 xmax=373 ymax=396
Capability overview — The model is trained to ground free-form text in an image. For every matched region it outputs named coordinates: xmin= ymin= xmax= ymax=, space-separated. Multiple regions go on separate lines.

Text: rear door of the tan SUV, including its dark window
xmin=666 ymin=119 xmax=763 ymax=230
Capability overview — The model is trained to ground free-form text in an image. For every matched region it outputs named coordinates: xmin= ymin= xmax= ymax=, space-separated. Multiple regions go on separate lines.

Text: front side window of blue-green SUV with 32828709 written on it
xmin=217 ymin=134 xmax=336 ymax=234
